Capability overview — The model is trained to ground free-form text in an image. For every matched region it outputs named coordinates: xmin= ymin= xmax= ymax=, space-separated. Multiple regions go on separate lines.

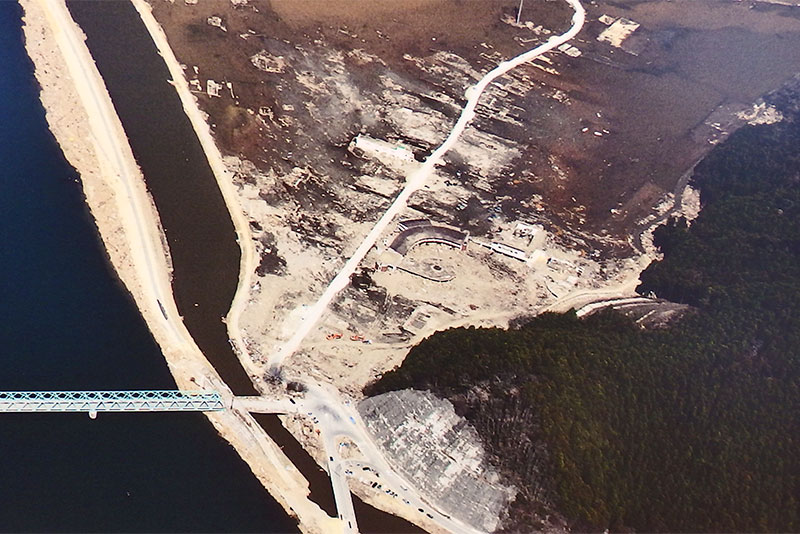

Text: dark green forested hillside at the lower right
xmin=367 ymin=102 xmax=800 ymax=532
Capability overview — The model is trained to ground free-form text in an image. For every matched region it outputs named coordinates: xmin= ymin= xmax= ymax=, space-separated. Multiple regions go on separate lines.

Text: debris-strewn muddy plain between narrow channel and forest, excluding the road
xmin=144 ymin=0 xmax=800 ymax=532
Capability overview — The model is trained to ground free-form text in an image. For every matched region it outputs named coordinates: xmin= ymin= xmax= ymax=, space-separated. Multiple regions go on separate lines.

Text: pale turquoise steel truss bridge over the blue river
xmin=0 ymin=390 xmax=225 ymax=417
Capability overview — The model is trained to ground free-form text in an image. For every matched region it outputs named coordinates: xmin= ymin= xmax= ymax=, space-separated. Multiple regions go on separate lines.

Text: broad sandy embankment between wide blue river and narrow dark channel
xmin=22 ymin=0 xmax=338 ymax=532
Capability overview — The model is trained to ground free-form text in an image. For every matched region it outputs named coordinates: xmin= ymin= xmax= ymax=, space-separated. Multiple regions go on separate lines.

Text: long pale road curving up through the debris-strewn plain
xmin=269 ymin=0 xmax=586 ymax=368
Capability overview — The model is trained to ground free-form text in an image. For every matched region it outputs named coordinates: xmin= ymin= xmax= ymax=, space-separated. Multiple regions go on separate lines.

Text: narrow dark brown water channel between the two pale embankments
xmin=10 ymin=0 xmax=419 ymax=533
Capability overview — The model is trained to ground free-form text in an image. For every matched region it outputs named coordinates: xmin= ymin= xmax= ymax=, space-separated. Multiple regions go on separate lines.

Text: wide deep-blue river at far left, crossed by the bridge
xmin=0 ymin=1 xmax=296 ymax=532
